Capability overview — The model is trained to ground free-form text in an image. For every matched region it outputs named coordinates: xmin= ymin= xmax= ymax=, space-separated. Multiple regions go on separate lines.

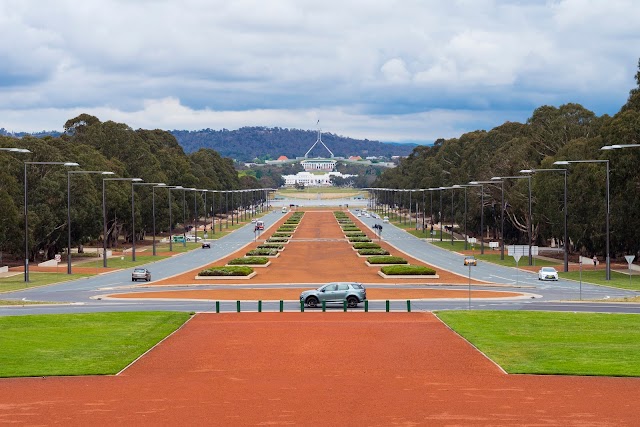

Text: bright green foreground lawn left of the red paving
xmin=0 ymin=312 xmax=189 ymax=377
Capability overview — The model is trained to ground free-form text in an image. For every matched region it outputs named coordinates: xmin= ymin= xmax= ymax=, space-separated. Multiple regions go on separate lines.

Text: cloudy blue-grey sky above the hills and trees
xmin=0 ymin=0 xmax=640 ymax=143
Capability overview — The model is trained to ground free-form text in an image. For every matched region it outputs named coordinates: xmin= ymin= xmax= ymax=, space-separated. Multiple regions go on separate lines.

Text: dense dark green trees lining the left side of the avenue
xmin=0 ymin=114 xmax=260 ymax=261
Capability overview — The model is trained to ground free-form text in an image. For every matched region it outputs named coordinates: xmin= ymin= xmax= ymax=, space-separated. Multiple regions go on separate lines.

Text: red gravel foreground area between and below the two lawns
xmin=0 ymin=313 xmax=640 ymax=426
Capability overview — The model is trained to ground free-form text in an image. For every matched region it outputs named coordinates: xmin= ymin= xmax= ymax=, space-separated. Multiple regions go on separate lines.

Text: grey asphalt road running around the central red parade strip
xmin=0 ymin=199 xmax=640 ymax=315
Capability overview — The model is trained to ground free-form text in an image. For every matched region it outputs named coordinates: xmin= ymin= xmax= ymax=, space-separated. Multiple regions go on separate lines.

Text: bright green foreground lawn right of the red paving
xmin=437 ymin=311 xmax=640 ymax=376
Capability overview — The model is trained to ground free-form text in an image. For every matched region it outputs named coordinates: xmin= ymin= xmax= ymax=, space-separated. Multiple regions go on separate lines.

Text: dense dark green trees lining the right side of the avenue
xmin=374 ymin=61 xmax=640 ymax=261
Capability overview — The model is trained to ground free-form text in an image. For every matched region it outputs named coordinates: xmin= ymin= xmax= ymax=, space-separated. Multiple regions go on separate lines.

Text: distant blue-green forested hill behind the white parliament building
xmin=171 ymin=127 xmax=417 ymax=161
